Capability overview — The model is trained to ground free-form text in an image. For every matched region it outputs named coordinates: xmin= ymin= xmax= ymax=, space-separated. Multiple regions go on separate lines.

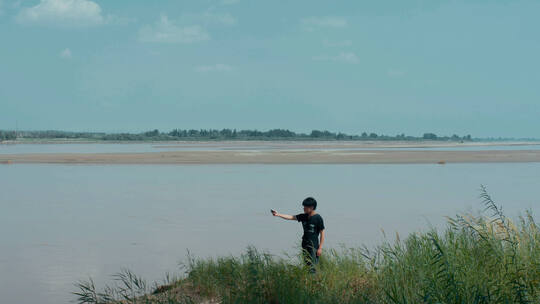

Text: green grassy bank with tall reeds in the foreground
xmin=76 ymin=189 xmax=540 ymax=303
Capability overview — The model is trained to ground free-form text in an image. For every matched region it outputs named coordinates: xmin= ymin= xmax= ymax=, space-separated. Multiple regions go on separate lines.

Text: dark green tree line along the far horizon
xmin=0 ymin=129 xmax=473 ymax=141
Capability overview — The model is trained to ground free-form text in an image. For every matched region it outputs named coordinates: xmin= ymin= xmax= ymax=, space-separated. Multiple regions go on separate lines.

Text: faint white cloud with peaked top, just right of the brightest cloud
xmin=139 ymin=15 xmax=210 ymax=44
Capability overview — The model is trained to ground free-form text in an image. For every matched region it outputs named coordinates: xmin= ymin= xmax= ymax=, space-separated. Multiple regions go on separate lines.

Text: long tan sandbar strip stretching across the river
xmin=0 ymin=150 xmax=540 ymax=164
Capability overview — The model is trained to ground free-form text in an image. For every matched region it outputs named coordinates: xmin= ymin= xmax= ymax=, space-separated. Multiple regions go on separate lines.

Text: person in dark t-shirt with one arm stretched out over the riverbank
xmin=272 ymin=197 xmax=324 ymax=273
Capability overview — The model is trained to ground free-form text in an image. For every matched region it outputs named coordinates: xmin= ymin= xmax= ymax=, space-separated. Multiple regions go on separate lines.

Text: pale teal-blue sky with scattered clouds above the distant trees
xmin=0 ymin=0 xmax=540 ymax=138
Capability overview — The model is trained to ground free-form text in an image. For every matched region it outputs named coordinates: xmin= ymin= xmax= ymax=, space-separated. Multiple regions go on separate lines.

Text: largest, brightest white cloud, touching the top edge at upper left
xmin=16 ymin=0 xmax=107 ymax=27
